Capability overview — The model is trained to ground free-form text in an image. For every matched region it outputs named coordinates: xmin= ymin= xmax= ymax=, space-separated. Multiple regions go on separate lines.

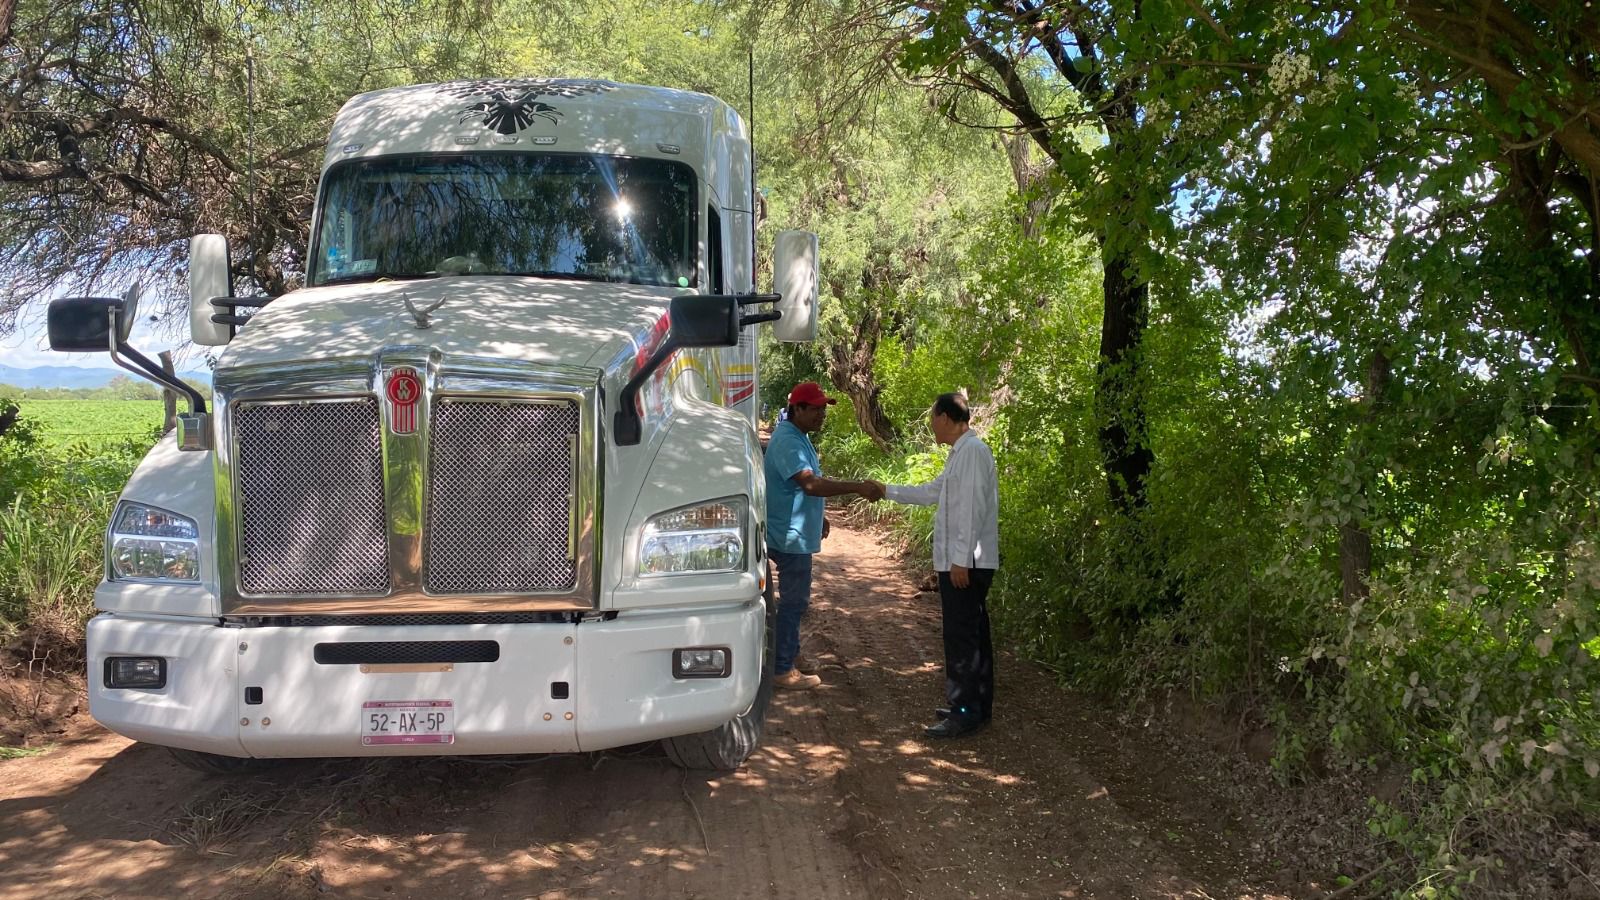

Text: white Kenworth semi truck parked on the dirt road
xmin=50 ymin=78 xmax=816 ymax=772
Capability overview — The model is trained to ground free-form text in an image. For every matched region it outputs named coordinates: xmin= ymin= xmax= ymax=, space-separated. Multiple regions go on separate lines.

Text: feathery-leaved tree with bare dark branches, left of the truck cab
xmin=0 ymin=0 xmax=499 ymax=327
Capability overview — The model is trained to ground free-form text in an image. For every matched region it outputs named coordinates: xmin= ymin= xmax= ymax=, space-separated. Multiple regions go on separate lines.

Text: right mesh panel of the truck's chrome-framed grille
xmin=426 ymin=397 xmax=579 ymax=594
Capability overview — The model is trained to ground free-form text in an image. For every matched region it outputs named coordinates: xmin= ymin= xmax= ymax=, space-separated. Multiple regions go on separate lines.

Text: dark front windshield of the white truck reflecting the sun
xmin=309 ymin=152 xmax=698 ymax=287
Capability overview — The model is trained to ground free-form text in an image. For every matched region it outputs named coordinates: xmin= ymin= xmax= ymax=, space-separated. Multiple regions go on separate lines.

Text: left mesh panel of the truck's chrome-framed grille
xmin=234 ymin=397 xmax=389 ymax=596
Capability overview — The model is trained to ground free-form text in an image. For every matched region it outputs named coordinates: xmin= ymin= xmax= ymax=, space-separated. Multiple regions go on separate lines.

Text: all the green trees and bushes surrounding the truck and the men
xmin=0 ymin=0 xmax=1600 ymax=897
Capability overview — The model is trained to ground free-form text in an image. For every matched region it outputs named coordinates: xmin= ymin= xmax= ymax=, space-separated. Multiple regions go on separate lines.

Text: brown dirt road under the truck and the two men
xmin=0 ymin=528 xmax=1326 ymax=900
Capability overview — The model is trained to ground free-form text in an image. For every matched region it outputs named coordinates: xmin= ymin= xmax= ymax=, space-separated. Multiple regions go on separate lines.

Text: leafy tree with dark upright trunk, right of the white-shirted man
xmin=893 ymin=2 xmax=1305 ymax=512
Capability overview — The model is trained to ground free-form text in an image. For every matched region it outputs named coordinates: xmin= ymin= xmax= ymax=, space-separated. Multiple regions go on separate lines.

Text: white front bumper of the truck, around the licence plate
xmin=88 ymin=597 xmax=765 ymax=757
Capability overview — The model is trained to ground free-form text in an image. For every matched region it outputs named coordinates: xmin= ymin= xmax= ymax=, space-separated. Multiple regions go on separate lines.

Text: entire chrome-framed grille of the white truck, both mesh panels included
xmin=225 ymin=365 xmax=600 ymax=617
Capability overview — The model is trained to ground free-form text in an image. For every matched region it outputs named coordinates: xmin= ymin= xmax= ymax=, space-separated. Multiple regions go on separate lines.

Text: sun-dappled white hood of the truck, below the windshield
xmin=218 ymin=275 xmax=678 ymax=375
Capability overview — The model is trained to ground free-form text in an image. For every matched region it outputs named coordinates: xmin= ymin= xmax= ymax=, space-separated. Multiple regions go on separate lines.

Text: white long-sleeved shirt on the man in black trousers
xmin=886 ymin=431 xmax=1000 ymax=572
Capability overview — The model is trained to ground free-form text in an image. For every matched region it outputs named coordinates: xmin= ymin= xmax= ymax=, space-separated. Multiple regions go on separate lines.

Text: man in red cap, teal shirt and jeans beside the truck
xmin=763 ymin=381 xmax=883 ymax=690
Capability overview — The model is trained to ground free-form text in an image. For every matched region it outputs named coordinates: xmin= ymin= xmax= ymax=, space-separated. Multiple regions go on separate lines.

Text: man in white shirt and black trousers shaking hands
xmin=883 ymin=394 xmax=1000 ymax=738
